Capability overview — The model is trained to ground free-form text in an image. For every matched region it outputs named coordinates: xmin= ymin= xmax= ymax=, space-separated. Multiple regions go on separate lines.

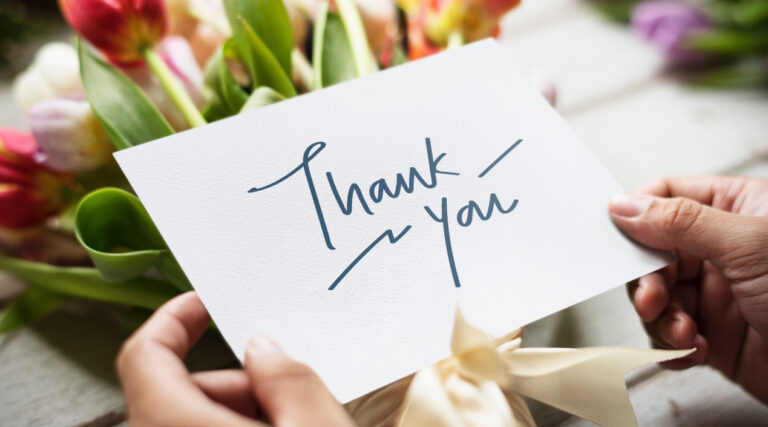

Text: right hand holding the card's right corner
xmin=609 ymin=177 xmax=768 ymax=403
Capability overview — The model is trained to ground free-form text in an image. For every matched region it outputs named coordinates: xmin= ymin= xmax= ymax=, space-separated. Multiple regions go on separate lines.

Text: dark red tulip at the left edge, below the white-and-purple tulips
xmin=0 ymin=129 xmax=72 ymax=228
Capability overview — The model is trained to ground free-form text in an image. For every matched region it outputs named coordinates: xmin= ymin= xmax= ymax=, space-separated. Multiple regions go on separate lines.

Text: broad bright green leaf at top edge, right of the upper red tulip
xmin=224 ymin=0 xmax=293 ymax=84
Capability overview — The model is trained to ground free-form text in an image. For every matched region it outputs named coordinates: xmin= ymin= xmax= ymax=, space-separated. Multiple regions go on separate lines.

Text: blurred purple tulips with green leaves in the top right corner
xmin=598 ymin=0 xmax=768 ymax=87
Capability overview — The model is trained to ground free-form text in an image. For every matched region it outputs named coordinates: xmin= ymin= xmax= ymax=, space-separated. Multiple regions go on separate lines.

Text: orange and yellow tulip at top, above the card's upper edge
xmin=397 ymin=0 xmax=520 ymax=59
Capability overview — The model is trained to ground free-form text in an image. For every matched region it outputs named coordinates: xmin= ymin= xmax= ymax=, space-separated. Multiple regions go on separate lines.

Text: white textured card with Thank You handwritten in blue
xmin=116 ymin=41 xmax=668 ymax=402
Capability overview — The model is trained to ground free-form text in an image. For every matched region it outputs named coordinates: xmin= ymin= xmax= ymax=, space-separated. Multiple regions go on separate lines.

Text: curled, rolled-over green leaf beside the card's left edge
xmin=75 ymin=188 xmax=191 ymax=291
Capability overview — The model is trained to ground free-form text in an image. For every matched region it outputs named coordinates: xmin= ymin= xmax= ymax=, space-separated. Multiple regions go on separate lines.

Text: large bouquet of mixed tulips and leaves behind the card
xmin=0 ymin=0 xmax=536 ymax=332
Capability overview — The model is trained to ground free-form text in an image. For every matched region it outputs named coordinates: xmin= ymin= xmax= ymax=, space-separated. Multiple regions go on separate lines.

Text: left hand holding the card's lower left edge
xmin=117 ymin=292 xmax=353 ymax=426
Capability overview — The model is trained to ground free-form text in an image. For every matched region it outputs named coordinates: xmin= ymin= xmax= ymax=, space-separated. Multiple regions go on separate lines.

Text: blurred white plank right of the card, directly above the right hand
xmin=566 ymin=78 xmax=768 ymax=188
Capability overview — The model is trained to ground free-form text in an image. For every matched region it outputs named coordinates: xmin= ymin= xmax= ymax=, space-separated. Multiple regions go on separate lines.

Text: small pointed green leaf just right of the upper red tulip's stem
xmin=203 ymin=38 xmax=248 ymax=121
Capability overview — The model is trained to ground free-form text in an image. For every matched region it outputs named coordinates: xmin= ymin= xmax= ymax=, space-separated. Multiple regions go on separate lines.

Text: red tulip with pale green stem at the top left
xmin=59 ymin=0 xmax=205 ymax=127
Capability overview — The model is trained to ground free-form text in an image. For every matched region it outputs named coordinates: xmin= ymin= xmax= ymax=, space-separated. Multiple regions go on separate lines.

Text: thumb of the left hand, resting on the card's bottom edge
xmin=245 ymin=337 xmax=353 ymax=426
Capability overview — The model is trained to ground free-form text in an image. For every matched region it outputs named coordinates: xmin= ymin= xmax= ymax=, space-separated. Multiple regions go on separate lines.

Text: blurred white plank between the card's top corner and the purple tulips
xmin=501 ymin=6 xmax=664 ymax=111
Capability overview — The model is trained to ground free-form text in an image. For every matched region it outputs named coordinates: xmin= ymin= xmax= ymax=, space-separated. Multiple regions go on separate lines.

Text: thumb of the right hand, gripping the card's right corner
xmin=608 ymin=194 xmax=765 ymax=267
